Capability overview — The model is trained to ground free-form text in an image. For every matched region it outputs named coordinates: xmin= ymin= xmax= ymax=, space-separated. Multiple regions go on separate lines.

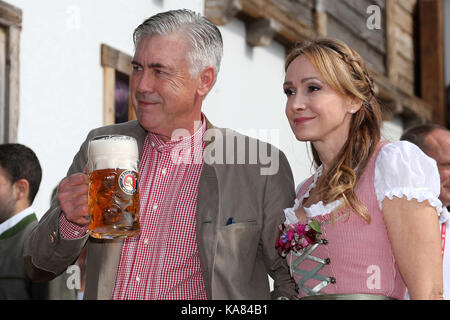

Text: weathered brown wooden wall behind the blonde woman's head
xmin=205 ymin=0 xmax=445 ymax=125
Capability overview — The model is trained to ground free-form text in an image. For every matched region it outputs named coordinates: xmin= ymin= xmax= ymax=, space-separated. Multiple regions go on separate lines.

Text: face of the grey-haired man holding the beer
xmin=130 ymin=34 xmax=203 ymax=139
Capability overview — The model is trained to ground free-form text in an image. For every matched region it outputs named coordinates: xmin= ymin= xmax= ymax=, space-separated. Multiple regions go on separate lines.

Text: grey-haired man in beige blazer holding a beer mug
xmin=25 ymin=10 xmax=296 ymax=299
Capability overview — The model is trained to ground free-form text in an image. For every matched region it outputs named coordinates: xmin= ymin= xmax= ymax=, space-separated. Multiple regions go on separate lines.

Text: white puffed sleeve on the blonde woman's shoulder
xmin=374 ymin=141 xmax=442 ymax=215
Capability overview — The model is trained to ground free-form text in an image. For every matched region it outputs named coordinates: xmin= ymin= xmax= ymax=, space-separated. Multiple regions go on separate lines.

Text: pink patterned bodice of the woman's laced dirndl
xmin=287 ymin=143 xmax=407 ymax=299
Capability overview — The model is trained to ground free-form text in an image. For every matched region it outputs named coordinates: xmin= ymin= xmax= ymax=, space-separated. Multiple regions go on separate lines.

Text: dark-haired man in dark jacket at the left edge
xmin=0 ymin=144 xmax=74 ymax=300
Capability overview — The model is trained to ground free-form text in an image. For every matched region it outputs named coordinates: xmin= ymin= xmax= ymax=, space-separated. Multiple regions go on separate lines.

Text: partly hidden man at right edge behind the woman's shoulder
xmin=400 ymin=123 xmax=450 ymax=300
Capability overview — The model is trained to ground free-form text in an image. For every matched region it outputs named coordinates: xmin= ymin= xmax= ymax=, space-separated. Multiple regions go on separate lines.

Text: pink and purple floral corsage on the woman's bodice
xmin=275 ymin=219 xmax=322 ymax=258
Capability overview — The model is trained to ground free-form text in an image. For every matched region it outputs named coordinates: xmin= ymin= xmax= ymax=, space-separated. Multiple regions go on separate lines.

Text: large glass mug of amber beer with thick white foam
xmin=88 ymin=135 xmax=139 ymax=239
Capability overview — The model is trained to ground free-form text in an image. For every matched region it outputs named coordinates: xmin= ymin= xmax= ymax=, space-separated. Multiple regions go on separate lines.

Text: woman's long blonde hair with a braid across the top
xmin=285 ymin=39 xmax=381 ymax=223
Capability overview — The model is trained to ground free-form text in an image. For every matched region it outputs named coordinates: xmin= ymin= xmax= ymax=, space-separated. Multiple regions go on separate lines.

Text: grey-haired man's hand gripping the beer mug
xmin=58 ymin=168 xmax=89 ymax=227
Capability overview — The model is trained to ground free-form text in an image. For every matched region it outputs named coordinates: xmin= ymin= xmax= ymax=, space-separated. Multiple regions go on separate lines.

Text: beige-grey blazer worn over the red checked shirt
xmin=24 ymin=121 xmax=296 ymax=299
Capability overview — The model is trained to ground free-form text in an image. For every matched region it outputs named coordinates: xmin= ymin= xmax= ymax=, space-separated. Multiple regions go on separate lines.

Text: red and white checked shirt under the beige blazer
xmin=60 ymin=121 xmax=207 ymax=300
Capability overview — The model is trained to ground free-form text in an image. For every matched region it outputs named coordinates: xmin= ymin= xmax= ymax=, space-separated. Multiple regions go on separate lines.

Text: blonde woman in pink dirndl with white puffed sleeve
xmin=277 ymin=39 xmax=442 ymax=299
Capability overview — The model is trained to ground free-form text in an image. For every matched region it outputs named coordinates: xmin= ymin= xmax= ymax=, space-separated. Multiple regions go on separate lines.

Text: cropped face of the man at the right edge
xmin=425 ymin=129 xmax=450 ymax=206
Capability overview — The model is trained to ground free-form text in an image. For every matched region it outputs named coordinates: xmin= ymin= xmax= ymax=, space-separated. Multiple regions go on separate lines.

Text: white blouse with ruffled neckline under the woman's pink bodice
xmin=284 ymin=141 xmax=448 ymax=224
